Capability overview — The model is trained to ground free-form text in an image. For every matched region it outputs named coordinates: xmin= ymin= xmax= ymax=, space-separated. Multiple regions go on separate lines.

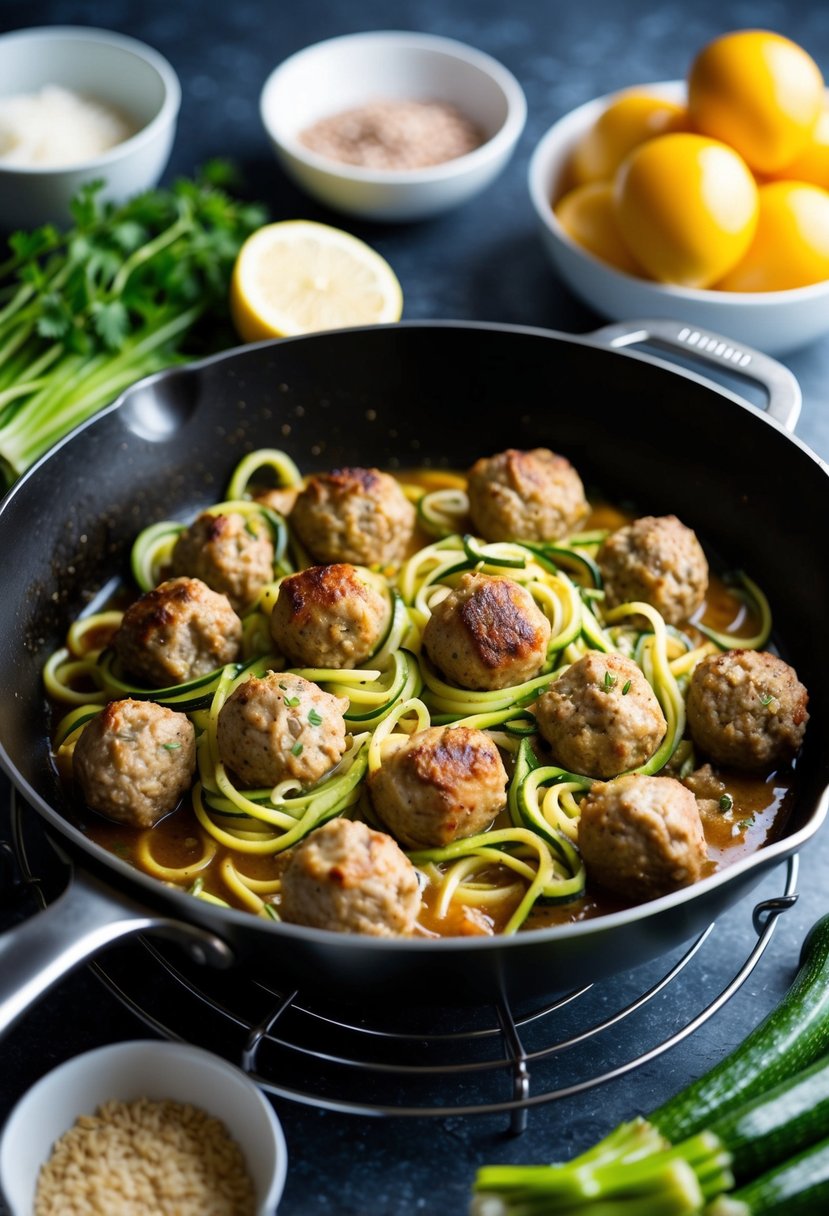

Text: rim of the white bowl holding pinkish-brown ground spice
xmin=259 ymin=29 xmax=526 ymax=185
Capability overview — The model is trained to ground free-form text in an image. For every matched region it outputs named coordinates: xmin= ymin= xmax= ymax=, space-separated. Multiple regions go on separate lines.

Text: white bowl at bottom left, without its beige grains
xmin=0 ymin=1040 xmax=288 ymax=1216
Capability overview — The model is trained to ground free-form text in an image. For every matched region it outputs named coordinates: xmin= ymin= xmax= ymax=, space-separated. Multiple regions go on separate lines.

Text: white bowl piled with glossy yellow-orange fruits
xmin=529 ymin=30 xmax=829 ymax=355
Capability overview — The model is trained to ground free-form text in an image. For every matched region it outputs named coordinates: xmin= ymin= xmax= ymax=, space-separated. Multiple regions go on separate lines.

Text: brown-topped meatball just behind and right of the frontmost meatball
xmin=368 ymin=726 xmax=507 ymax=849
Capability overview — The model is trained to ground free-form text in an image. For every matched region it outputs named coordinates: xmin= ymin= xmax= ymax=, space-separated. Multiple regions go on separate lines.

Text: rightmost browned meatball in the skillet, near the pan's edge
xmin=687 ymin=649 xmax=808 ymax=772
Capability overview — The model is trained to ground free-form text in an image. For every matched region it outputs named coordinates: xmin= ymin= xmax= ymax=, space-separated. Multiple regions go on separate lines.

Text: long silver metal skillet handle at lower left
xmin=0 ymin=873 xmax=233 ymax=1037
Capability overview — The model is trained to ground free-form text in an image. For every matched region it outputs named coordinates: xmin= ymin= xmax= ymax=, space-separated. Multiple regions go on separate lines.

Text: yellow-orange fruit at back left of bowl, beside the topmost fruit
xmin=570 ymin=89 xmax=688 ymax=185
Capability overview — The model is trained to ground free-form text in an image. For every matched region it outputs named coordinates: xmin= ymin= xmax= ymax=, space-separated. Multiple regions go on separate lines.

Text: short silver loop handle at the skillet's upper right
xmin=590 ymin=320 xmax=802 ymax=433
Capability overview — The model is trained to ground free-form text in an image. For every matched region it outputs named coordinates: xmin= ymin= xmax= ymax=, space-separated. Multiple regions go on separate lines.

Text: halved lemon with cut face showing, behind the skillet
xmin=230 ymin=220 xmax=402 ymax=342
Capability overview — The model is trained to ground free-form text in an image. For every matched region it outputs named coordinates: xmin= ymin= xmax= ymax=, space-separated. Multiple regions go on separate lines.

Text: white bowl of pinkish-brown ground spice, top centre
xmin=260 ymin=30 xmax=526 ymax=223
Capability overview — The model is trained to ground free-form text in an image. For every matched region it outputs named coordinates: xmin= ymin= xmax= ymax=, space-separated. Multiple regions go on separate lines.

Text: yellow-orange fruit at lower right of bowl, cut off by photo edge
xmin=717 ymin=181 xmax=829 ymax=292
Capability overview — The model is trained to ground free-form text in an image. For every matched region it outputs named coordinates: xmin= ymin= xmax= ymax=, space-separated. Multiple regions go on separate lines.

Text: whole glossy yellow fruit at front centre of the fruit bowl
xmin=614 ymin=133 xmax=757 ymax=287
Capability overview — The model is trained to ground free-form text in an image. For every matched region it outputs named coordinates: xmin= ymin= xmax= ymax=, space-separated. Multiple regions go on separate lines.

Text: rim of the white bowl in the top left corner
xmin=0 ymin=26 xmax=181 ymax=178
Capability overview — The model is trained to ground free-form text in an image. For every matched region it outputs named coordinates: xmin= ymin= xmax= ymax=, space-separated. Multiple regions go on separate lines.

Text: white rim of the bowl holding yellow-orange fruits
xmin=529 ymin=80 xmax=829 ymax=309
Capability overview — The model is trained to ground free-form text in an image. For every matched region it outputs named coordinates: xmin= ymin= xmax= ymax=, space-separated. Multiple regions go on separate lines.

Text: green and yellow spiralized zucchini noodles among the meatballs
xmin=43 ymin=449 xmax=772 ymax=934
